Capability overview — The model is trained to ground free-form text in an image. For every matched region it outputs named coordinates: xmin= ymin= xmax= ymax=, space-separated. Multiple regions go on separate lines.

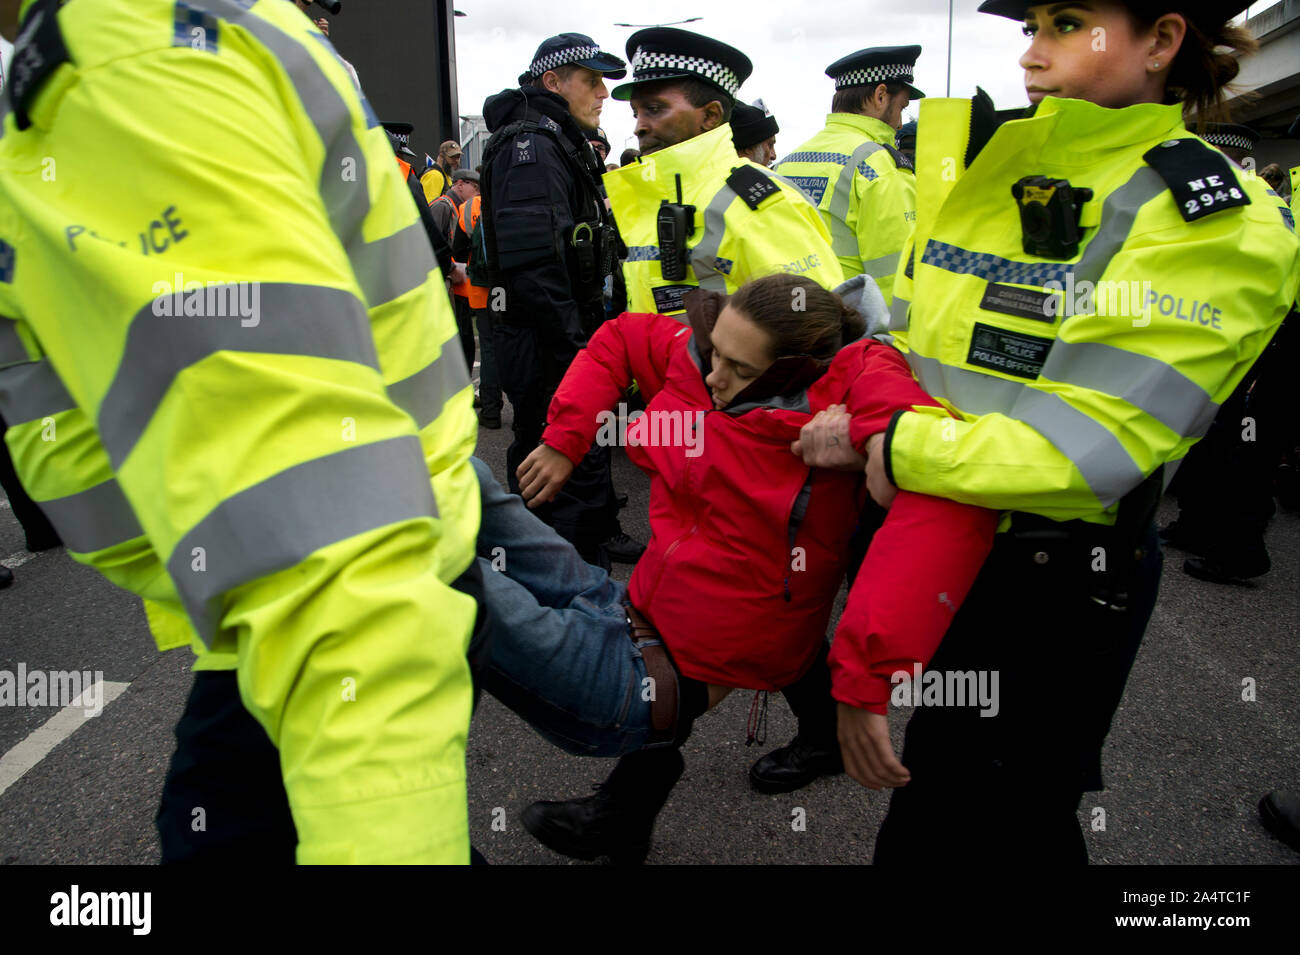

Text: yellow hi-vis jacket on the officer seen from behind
xmin=776 ymin=113 xmax=917 ymax=304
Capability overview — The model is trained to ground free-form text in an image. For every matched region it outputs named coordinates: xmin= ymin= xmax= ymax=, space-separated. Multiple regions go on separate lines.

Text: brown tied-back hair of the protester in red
xmin=727 ymin=273 xmax=867 ymax=361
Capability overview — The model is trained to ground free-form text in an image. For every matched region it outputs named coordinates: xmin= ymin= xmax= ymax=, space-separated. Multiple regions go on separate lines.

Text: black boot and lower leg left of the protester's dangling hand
xmin=749 ymin=646 xmax=844 ymax=793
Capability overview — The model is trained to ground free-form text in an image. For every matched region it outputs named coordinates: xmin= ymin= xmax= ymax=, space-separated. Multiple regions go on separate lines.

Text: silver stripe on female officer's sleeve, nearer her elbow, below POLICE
xmin=1041 ymin=339 xmax=1218 ymax=438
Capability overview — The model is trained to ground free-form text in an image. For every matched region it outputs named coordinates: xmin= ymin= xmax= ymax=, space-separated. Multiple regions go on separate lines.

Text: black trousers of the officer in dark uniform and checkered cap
xmin=493 ymin=321 xmax=619 ymax=567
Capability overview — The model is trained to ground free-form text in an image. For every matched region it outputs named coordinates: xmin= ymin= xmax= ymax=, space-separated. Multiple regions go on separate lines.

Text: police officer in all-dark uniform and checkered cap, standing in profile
xmin=480 ymin=34 xmax=645 ymax=568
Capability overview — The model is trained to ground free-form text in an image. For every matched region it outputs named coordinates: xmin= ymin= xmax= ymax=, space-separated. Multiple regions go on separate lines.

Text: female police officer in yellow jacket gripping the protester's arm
xmin=831 ymin=0 xmax=1300 ymax=863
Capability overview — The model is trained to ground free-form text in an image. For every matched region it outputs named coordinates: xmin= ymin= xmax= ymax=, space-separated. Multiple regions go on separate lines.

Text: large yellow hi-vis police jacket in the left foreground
xmin=0 ymin=0 xmax=480 ymax=863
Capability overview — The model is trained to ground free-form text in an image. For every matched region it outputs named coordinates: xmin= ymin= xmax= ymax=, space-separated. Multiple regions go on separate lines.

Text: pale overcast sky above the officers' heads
xmin=454 ymin=0 xmax=1275 ymax=160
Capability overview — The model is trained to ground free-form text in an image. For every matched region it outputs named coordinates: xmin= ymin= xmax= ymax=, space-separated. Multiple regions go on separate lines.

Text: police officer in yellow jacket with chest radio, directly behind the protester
xmin=605 ymin=27 xmax=841 ymax=316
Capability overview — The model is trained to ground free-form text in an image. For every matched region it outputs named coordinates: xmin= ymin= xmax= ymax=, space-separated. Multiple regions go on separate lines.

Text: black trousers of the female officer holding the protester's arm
xmin=875 ymin=528 xmax=1162 ymax=865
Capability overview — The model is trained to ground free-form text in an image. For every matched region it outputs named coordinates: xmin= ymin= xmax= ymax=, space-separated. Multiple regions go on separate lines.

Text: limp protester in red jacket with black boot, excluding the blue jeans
xmin=499 ymin=275 xmax=996 ymax=858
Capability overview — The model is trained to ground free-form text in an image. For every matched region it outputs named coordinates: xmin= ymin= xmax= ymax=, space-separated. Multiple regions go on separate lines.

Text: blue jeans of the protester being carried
xmin=471 ymin=457 xmax=650 ymax=756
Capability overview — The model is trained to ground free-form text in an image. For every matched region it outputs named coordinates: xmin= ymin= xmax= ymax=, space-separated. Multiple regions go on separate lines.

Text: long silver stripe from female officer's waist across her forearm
xmin=907 ymin=350 xmax=1143 ymax=507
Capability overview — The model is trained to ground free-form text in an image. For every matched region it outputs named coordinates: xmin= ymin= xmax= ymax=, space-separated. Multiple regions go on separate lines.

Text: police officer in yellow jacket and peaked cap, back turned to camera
xmin=776 ymin=45 xmax=926 ymax=304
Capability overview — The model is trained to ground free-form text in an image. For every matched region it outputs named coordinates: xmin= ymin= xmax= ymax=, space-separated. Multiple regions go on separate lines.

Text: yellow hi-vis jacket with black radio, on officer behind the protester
xmin=603 ymin=123 xmax=842 ymax=314
